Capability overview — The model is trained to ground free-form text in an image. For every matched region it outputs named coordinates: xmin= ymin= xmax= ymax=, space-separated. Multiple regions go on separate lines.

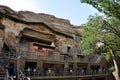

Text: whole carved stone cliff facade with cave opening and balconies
xmin=0 ymin=6 xmax=109 ymax=79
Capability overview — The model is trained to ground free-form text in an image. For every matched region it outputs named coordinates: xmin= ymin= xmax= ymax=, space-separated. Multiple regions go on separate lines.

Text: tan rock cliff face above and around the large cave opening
xmin=0 ymin=6 xmax=81 ymax=53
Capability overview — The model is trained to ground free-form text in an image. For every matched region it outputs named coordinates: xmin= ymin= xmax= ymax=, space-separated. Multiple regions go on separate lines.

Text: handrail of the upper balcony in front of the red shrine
xmin=18 ymin=50 xmax=86 ymax=62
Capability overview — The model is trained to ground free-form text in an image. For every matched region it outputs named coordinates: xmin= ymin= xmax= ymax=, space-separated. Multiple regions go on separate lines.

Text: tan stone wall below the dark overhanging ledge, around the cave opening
xmin=2 ymin=18 xmax=79 ymax=53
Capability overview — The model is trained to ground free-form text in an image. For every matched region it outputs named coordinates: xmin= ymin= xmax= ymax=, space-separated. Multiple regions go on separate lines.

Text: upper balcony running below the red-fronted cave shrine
xmin=18 ymin=51 xmax=87 ymax=63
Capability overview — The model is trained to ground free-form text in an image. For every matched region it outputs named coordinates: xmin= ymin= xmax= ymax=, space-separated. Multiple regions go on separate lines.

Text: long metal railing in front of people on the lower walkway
xmin=24 ymin=71 xmax=109 ymax=77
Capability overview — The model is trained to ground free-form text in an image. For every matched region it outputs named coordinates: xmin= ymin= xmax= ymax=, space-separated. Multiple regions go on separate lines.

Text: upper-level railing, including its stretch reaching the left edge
xmin=2 ymin=50 xmax=88 ymax=62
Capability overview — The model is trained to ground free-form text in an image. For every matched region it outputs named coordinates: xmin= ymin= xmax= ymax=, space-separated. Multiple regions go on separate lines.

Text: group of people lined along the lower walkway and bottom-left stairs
xmin=6 ymin=64 xmax=106 ymax=80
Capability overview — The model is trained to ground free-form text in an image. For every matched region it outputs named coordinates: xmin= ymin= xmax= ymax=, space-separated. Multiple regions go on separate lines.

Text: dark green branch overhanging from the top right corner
xmin=80 ymin=0 xmax=120 ymax=19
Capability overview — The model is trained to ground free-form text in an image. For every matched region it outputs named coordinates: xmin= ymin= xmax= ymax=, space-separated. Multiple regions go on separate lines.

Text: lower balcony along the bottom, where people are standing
xmin=24 ymin=71 xmax=110 ymax=80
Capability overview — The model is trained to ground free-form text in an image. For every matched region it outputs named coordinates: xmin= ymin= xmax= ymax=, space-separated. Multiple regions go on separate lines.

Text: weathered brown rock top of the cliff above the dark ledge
xmin=0 ymin=6 xmax=81 ymax=36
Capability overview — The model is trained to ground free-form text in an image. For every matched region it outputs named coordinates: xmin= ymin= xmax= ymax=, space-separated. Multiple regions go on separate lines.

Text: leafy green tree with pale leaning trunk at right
xmin=80 ymin=16 xmax=120 ymax=80
